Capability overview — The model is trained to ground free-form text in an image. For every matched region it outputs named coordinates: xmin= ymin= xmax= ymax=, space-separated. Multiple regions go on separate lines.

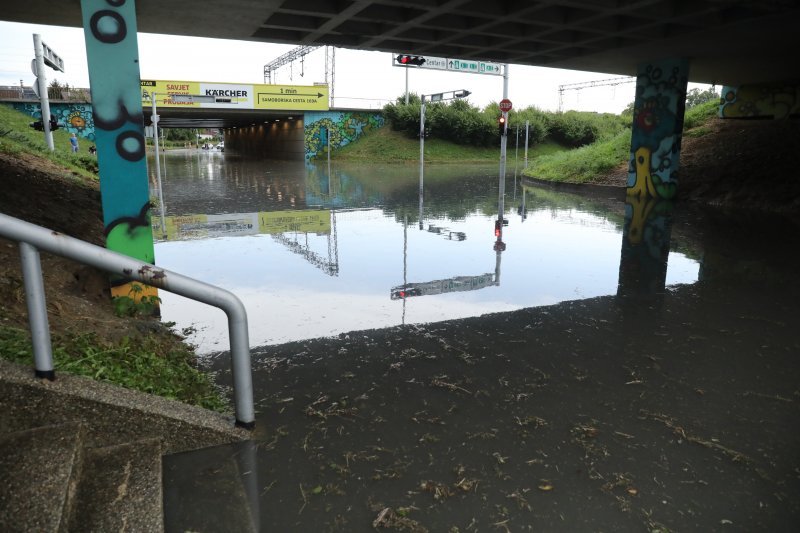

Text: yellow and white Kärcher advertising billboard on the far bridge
xmin=141 ymin=80 xmax=329 ymax=111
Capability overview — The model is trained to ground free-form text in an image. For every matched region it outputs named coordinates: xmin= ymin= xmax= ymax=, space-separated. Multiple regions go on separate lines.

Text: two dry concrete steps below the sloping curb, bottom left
xmin=0 ymin=422 xmax=164 ymax=532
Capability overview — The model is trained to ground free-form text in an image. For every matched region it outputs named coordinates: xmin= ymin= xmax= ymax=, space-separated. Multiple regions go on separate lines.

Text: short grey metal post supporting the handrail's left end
xmin=19 ymin=242 xmax=56 ymax=381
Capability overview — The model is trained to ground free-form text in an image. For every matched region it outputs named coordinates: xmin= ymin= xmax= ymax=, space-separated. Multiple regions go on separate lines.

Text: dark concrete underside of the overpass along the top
xmin=0 ymin=0 xmax=800 ymax=85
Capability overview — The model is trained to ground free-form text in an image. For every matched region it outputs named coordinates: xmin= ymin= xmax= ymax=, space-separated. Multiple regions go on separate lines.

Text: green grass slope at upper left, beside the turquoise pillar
xmin=0 ymin=105 xmax=97 ymax=180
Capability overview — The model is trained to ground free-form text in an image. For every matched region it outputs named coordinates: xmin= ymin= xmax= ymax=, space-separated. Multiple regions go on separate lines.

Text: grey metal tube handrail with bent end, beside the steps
xmin=0 ymin=213 xmax=255 ymax=429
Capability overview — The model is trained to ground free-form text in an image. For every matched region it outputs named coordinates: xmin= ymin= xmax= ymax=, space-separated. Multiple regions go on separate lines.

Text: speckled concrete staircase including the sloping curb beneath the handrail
xmin=0 ymin=360 xmax=250 ymax=533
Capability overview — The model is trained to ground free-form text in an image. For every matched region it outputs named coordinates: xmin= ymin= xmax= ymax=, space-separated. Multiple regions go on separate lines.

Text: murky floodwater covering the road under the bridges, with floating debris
xmin=154 ymin=152 xmax=800 ymax=532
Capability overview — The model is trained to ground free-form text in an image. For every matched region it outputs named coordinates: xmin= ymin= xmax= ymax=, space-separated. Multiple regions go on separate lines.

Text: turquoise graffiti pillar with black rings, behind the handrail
xmin=81 ymin=0 xmax=156 ymax=299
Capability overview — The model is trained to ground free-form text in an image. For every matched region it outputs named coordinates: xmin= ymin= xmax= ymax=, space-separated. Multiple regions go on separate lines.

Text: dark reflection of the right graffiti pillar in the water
xmin=617 ymin=196 xmax=672 ymax=297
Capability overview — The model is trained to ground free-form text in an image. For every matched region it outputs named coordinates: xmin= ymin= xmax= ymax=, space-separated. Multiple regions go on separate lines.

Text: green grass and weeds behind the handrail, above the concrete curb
xmin=0 ymin=326 xmax=227 ymax=411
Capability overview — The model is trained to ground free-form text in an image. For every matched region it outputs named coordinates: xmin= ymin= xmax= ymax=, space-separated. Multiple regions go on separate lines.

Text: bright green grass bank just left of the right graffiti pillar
xmin=525 ymin=130 xmax=631 ymax=183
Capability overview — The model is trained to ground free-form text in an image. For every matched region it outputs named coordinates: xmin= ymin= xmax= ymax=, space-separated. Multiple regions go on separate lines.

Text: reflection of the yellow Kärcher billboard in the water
xmin=152 ymin=210 xmax=331 ymax=241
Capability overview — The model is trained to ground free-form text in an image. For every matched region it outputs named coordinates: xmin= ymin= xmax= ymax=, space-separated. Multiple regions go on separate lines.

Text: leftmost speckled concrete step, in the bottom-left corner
xmin=0 ymin=423 xmax=84 ymax=532
